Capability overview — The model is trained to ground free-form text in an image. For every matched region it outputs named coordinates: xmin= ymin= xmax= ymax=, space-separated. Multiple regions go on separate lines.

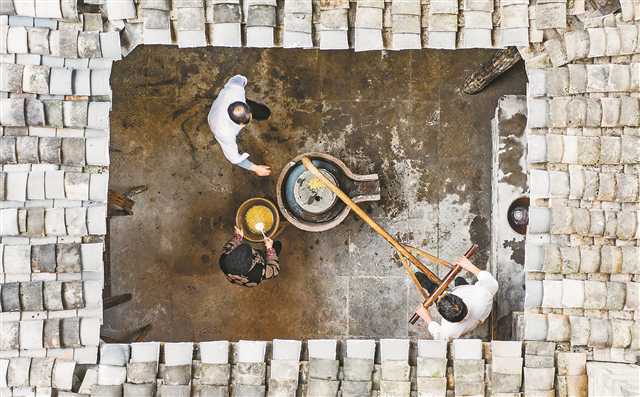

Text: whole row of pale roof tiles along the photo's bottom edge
xmin=0 ymin=339 xmax=587 ymax=397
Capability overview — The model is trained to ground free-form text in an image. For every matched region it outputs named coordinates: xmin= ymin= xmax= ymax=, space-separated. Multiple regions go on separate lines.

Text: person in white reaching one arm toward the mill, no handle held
xmin=207 ymin=74 xmax=271 ymax=176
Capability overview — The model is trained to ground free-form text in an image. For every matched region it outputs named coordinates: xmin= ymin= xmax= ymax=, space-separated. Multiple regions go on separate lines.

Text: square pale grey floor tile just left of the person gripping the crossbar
xmin=348 ymin=277 xmax=408 ymax=337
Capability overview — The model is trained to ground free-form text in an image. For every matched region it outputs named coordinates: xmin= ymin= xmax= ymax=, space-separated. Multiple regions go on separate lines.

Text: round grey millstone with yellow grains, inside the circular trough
xmin=293 ymin=169 xmax=337 ymax=214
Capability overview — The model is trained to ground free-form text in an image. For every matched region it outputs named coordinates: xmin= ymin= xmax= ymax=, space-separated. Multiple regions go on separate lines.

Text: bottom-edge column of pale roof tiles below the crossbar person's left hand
xmin=416 ymin=340 xmax=447 ymax=397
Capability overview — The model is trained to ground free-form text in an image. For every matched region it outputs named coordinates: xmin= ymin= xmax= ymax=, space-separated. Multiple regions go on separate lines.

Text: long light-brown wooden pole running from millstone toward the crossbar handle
xmin=302 ymin=157 xmax=442 ymax=285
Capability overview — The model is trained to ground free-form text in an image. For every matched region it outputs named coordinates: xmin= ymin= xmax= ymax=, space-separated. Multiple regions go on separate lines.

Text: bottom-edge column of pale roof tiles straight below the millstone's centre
xmin=305 ymin=339 xmax=340 ymax=397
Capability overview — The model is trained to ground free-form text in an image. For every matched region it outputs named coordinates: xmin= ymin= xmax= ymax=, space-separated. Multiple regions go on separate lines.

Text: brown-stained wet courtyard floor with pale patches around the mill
xmin=105 ymin=46 xmax=525 ymax=341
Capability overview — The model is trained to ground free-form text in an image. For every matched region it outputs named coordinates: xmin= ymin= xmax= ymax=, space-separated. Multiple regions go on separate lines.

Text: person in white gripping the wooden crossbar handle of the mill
xmin=416 ymin=257 xmax=498 ymax=340
